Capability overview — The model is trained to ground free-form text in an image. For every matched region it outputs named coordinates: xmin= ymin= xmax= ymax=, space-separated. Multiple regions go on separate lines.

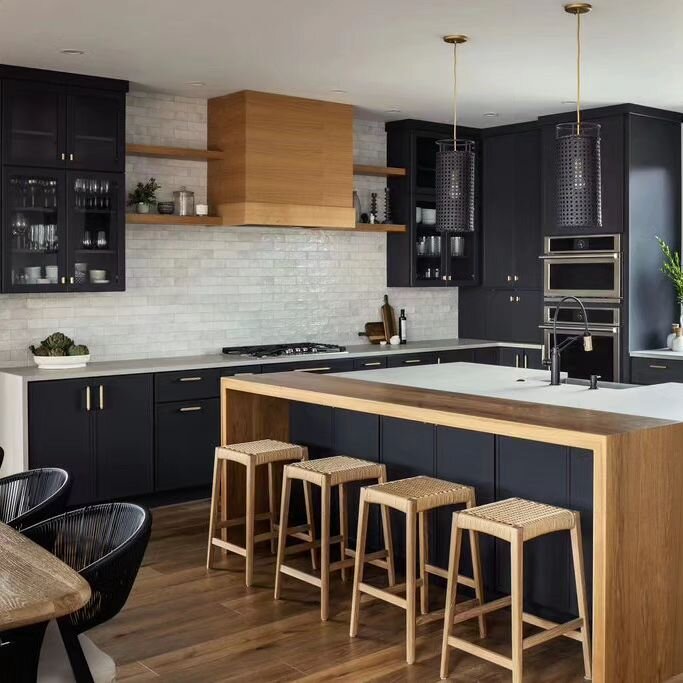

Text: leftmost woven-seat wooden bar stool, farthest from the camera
xmin=206 ymin=439 xmax=316 ymax=586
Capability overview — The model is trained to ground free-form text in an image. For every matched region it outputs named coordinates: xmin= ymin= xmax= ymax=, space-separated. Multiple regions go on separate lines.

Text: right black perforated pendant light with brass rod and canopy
xmin=555 ymin=2 xmax=602 ymax=231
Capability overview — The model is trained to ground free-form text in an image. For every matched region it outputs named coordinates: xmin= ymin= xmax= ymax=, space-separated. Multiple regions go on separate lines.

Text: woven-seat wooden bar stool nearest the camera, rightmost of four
xmin=441 ymin=498 xmax=591 ymax=683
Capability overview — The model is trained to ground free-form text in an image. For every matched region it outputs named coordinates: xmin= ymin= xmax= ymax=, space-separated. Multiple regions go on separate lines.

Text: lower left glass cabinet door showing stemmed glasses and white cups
xmin=2 ymin=166 xmax=68 ymax=292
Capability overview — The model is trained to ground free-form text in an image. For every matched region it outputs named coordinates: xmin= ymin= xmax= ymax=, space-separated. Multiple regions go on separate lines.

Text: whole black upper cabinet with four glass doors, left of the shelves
xmin=0 ymin=66 xmax=128 ymax=293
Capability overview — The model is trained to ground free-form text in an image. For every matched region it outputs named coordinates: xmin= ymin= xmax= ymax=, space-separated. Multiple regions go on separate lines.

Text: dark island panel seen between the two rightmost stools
xmin=433 ymin=427 xmax=496 ymax=593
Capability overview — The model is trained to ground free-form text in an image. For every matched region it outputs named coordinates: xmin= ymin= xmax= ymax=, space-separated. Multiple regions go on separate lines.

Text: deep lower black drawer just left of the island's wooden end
xmin=155 ymin=398 xmax=220 ymax=491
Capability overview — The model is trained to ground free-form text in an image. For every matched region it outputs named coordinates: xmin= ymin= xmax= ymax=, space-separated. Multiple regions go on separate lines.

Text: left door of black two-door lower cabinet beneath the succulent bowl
xmin=28 ymin=379 xmax=96 ymax=505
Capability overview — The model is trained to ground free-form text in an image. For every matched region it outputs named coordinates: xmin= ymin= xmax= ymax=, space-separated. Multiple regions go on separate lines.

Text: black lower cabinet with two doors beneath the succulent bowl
xmin=28 ymin=375 xmax=154 ymax=505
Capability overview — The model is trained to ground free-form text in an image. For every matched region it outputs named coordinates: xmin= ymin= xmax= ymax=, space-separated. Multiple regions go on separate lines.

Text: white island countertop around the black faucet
xmin=337 ymin=363 xmax=683 ymax=422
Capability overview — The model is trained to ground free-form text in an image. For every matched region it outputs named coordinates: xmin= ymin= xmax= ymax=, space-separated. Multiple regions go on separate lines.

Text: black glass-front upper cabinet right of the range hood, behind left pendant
xmin=386 ymin=120 xmax=481 ymax=287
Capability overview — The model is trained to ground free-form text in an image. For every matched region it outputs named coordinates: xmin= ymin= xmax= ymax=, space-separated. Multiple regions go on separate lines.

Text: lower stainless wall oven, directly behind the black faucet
xmin=540 ymin=300 xmax=621 ymax=382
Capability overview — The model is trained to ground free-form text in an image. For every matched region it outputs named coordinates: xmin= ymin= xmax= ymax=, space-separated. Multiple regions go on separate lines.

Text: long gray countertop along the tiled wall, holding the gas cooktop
xmin=0 ymin=339 xmax=542 ymax=382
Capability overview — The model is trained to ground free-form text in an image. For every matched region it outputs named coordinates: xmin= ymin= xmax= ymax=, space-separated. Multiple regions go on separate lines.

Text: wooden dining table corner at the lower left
xmin=0 ymin=522 xmax=90 ymax=632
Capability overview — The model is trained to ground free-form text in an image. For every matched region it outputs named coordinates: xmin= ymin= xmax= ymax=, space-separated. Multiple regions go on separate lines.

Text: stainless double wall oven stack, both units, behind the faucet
xmin=540 ymin=235 xmax=623 ymax=382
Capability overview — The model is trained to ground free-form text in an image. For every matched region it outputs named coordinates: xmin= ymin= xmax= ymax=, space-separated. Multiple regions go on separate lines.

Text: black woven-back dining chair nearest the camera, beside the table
xmin=6 ymin=503 xmax=152 ymax=683
